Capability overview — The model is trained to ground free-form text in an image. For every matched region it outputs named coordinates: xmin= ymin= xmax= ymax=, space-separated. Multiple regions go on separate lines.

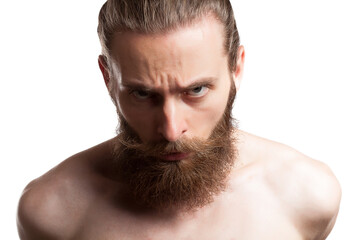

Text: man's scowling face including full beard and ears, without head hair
xmin=100 ymin=15 xmax=243 ymax=210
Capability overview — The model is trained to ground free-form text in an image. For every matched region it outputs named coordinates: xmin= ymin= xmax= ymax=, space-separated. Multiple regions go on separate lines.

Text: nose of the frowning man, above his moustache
xmin=158 ymin=99 xmax=187 ymax=142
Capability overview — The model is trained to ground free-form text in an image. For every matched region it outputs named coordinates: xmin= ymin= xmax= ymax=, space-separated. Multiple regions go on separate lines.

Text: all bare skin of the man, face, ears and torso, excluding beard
xmin=18 ymin=17 xmax=341 ymax=240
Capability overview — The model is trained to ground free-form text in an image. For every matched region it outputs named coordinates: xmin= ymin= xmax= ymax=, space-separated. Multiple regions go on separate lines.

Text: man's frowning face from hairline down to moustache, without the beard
xmin=102 ymin=18 xmax=239 ymax=145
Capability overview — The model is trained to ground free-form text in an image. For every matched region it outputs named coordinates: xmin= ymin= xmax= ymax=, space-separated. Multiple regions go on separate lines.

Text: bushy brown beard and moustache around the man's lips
xmin=114 ymin=84 xmax=236 ymax=210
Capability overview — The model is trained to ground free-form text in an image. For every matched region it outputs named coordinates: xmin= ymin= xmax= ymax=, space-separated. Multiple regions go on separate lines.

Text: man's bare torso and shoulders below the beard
xmin=18 ymin=133 xmax=341 ymax=240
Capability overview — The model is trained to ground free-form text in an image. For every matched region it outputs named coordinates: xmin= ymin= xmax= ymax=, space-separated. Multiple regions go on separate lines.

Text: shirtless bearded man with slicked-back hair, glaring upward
xmin=18 ymin=0 xmax=341 ymax=240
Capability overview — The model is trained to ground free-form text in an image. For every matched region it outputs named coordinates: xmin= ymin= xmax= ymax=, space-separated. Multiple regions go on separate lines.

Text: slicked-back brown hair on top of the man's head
xmin=97 ymin=0 xmax=240 ymax=71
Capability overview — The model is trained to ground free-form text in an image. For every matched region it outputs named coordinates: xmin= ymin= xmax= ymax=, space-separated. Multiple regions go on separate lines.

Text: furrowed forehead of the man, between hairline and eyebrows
xmin=111 ymin=17 xmax=227 ymax=87
